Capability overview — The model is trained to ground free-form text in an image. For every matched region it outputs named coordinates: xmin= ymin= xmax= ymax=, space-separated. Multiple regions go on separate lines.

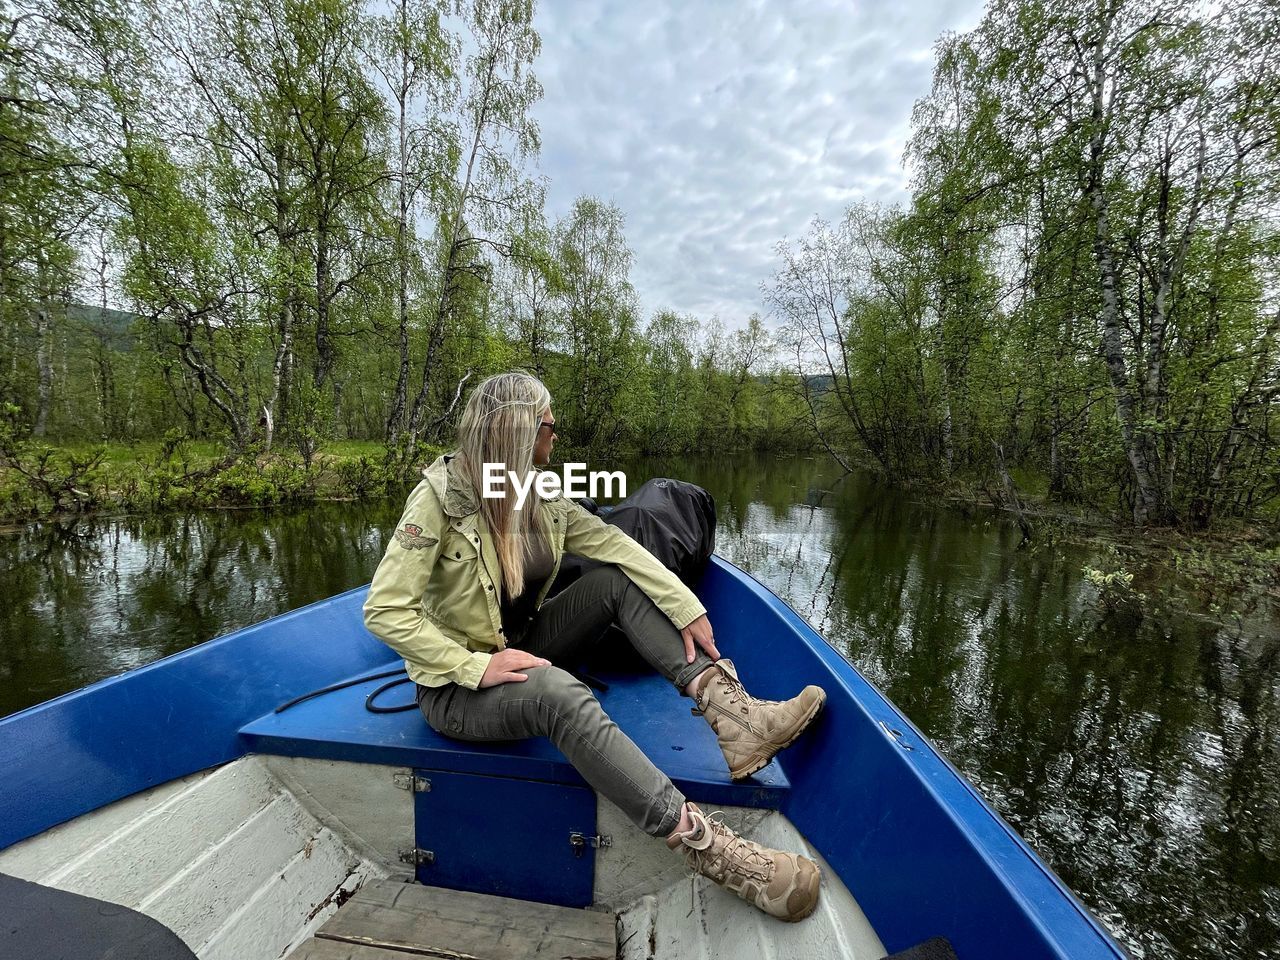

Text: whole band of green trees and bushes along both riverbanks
xmin=0 ymin=0 xmax=1280 ymax=539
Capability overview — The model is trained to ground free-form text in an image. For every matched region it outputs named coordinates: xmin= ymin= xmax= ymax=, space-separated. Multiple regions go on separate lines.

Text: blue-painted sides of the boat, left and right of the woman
xmin=0 ymin=558 xmax=1125 ymax=960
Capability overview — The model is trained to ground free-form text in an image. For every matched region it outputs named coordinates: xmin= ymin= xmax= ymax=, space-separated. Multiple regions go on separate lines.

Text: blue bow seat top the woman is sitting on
xmin=239 ymin=660 xmax=790 ymax=810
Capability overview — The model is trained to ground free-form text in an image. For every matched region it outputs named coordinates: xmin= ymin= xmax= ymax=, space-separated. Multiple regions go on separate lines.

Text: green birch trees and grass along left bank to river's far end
xmin=0 ymin=0 xmax=810 ymax=511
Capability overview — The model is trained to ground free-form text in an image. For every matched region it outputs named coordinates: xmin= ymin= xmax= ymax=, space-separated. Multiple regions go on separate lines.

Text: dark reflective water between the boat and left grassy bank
xmin=0 ymin=504 xmax=399 ymax=716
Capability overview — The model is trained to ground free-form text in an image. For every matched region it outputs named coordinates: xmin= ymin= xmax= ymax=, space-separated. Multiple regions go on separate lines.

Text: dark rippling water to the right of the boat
xmin=645 ymin=462 xmax=1280 ymax=960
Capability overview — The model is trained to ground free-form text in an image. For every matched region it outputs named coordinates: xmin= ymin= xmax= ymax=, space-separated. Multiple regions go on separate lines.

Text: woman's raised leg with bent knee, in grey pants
xmin=518 ymin=566 xmax=712 ymax=694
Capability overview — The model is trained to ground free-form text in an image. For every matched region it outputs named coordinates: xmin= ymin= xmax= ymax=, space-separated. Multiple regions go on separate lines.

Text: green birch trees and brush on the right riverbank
xmin=767 ymin=0 xmax=1280 ymax=531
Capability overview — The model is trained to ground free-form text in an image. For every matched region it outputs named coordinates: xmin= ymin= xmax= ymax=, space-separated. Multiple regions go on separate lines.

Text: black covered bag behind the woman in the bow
xmin=547 ymin=477 xmax=716 ymax=669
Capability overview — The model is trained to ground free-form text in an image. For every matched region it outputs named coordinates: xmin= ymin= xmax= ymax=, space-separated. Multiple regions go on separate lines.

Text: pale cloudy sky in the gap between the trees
xmin=524 ymin=0 xmax=982 ymax=326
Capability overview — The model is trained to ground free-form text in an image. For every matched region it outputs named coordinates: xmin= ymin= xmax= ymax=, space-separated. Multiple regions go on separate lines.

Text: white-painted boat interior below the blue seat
xmin=0 ymin=754 xmax=886 ymax=960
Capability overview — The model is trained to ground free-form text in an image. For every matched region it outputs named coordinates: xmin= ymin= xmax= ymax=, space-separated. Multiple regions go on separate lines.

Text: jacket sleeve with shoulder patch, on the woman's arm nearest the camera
xmin=365 ymin=483 xmax=490 ymax=690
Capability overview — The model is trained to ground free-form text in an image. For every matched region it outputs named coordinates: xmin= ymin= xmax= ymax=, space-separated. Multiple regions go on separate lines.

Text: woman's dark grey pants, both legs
xmin=417 ymin=566 xmax=712 ymax=837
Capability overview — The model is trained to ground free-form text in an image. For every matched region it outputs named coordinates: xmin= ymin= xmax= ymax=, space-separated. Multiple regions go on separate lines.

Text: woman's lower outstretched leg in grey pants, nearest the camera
xmin=419 ymin=667 xmax=685 ymax=837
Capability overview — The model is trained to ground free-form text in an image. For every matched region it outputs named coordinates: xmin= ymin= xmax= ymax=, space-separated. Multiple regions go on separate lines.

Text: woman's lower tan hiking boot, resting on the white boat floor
xmin=667 ymin=803 xmax=822 ymax=923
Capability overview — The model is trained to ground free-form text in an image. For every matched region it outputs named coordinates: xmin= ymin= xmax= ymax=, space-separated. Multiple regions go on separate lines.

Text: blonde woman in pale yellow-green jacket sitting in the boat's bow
xmin=365 ymin=371 xmax=826 ymax=920
